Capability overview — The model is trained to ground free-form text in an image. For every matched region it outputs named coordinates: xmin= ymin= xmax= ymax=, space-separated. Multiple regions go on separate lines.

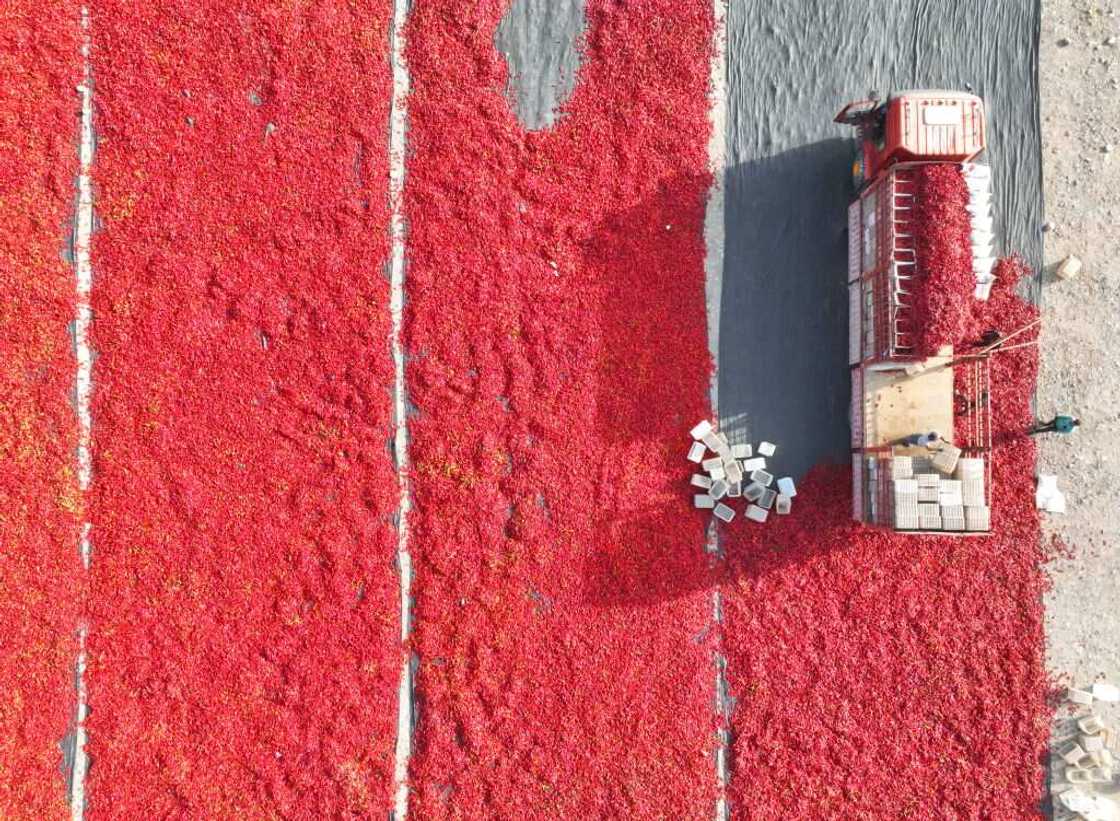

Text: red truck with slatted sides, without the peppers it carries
xmin=836 ymin=91 xmax=995 ymax=534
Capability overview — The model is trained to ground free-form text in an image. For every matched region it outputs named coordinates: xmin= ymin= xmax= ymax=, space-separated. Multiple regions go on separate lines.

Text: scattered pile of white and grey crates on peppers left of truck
xmin=689 ymin=420 xmax=797 ymax=522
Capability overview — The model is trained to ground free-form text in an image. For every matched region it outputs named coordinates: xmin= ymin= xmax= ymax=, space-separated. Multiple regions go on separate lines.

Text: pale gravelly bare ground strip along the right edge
xmin=1038 ymin=0 xmax=1120 ymax=792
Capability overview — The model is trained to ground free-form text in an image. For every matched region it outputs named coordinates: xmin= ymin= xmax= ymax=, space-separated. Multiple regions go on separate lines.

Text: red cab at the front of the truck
xmin=836 ymin=91 xmax=987 ymax=189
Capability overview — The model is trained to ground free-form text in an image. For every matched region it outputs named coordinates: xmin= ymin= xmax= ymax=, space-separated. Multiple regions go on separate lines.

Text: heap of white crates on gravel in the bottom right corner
xmin=1051 ymin=682 xmax=1120 ymax=821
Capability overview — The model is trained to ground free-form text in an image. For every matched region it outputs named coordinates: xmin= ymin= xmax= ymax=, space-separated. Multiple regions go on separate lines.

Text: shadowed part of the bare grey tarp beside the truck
xmin=719 ymin=139 xmax=852 ymax=479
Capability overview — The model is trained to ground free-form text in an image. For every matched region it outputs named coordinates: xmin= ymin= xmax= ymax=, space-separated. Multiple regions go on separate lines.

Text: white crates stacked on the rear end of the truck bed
xmin=890 ymin=456 xmax=991 ymax=531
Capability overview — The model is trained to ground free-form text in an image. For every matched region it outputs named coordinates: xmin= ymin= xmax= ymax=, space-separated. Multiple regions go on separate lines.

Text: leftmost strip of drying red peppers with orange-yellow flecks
xmin=0 ymin=0 xmax=84 ymax=819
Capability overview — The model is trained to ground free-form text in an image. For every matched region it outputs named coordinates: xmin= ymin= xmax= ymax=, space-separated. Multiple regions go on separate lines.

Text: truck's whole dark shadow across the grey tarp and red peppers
xmin=582 ymin=150 xmax=852 ymax=607
